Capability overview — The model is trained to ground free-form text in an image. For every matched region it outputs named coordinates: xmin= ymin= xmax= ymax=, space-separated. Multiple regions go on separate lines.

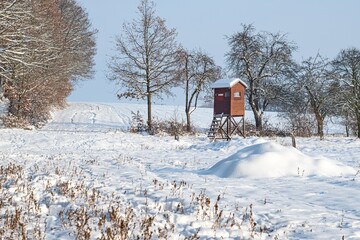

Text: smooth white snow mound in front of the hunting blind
xmin=205 ymin=142 xmax=356 ymax=178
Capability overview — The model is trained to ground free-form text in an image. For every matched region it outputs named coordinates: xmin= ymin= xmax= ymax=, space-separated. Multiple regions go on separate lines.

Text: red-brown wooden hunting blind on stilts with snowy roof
xmin=208 ymin=78 xmax=247 ymax=140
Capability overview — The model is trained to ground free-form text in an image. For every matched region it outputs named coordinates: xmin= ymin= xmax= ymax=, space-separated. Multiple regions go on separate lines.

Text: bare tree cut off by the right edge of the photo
xmin=332 ymin=48 xmax=360 ymax=138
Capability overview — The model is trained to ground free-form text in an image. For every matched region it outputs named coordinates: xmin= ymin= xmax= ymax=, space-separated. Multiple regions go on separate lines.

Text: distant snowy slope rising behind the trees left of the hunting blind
xmin=46 ymin=103 xmax=212 ymax=131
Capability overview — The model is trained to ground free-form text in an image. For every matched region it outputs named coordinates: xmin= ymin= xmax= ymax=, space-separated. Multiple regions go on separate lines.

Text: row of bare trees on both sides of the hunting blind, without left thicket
xmin=108 ymin=0 xmax=360 ymax=139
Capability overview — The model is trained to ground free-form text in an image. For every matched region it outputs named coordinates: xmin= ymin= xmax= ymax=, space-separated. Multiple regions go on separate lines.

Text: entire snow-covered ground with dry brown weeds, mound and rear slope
xmin=0 ymin=103 xmax=360 ymax=239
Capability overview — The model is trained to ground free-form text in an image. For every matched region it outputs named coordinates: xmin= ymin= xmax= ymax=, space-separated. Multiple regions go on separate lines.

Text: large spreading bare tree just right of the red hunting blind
xmin=226 ymin=25 xmax=296 ymax=131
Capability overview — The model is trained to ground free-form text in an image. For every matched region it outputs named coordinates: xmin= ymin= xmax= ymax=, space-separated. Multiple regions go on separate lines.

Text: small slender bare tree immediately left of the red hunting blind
xmin=181 ymin=50 xmax=221 ymax=132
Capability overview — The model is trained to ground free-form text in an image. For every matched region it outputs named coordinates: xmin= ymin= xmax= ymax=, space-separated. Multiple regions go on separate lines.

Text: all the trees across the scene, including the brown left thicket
xmin=0 ymin=0 xmax=360 ymax=138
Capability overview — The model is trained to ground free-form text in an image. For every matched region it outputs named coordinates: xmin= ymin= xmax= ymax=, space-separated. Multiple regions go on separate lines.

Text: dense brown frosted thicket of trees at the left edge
xmin=0 ymin=0 xmax=96 ymax=127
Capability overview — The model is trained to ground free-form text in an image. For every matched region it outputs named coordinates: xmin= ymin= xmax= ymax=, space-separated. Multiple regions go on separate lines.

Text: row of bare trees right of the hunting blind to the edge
xmin=226 ymin=25 xmax=360 ymax=139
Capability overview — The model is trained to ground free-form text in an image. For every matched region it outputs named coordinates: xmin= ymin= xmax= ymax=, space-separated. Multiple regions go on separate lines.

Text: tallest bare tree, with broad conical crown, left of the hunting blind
xmin=109 ymin=0 xmax=179 ymax=132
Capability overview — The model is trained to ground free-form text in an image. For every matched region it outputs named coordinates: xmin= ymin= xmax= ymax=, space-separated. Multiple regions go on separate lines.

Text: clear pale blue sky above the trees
xmin=68 ymin=0 xmax=360 ymax=105
